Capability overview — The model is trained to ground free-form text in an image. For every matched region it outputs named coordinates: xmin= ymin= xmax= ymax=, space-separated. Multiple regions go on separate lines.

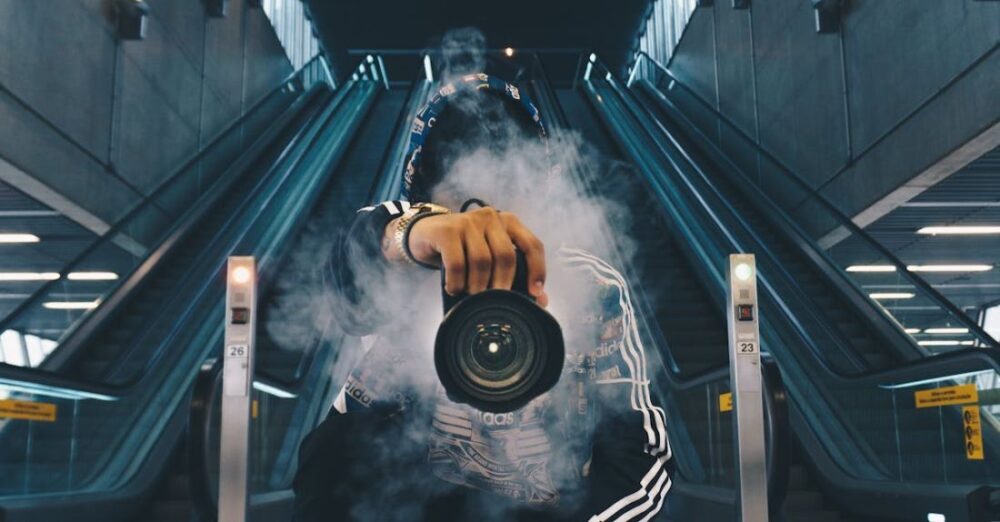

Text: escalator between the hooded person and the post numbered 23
xmin=531 ymin=54 xmax=790 ymax=520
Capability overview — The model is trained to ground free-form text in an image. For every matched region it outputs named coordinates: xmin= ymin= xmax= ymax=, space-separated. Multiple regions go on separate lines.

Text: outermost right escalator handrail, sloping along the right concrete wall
xmin=636 ymin=51 xmax=1000 ymax=349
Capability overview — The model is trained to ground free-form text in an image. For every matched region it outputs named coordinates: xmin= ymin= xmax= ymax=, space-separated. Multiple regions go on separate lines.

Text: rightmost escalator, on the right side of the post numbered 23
xmin=582 ymin=54 xmax=998 ymax=520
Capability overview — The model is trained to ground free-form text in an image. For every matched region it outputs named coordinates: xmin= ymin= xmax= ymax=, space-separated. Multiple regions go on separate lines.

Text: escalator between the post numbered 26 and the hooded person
xmin=182 ymin=61 xmax=440 ymax=520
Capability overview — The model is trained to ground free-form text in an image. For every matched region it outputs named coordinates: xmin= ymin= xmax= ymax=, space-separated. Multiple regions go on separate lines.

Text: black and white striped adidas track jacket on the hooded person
xmin=327 ymin=201 xmax=672 ymax=522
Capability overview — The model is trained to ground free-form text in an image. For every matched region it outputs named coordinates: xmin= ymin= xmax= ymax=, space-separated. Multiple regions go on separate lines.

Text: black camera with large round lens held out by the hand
xmin=434 ymin=252 xmax=566 ymax=413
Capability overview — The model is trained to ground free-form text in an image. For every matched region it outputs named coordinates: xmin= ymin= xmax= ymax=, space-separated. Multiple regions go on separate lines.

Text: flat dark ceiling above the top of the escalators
xmin=305 ymin=0 xmax=649 ymax=81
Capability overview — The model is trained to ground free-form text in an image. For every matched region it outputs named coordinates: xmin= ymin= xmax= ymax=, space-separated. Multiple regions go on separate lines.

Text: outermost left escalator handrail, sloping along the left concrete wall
xmin=0 ymin=55 xmax=324 ymax=338
